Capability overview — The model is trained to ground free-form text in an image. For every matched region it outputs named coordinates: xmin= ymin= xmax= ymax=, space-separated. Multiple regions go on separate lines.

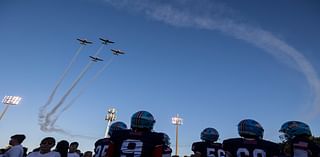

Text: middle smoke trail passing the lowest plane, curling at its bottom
xmin=40 ymin=45 xmax=103 ymax=133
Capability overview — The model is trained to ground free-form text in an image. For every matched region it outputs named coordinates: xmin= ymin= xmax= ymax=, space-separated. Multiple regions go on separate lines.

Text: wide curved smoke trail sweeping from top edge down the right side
xmin=105 ymin=0 xmax=320 ymax=119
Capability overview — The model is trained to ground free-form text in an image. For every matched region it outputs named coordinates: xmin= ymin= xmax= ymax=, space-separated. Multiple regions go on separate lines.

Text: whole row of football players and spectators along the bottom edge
xmin=0 ymin=111 xmax=320 ymax=157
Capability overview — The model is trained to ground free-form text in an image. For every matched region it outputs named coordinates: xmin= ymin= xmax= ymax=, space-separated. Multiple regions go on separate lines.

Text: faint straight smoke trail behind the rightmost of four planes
xmin=52 ymin=56 xmax=113 ymax=124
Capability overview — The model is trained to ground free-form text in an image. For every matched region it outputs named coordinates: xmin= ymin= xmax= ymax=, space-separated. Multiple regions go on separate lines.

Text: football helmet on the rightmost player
xmin=279 ymin=121 xmax=312 ymax=141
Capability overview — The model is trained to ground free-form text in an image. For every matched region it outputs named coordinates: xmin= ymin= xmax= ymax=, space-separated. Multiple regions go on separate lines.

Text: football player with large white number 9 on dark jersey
xmin=107 ymin=111 xmax=163 ymax=157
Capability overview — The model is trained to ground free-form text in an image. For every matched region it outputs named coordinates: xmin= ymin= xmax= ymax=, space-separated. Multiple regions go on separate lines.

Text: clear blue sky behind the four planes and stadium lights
xmin=0 ymin=0 xmax=320 ymax=155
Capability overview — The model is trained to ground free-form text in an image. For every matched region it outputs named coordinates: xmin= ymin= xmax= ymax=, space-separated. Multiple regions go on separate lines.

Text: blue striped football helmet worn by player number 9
xmin=131 ymin=111 xmax=156 ymax=130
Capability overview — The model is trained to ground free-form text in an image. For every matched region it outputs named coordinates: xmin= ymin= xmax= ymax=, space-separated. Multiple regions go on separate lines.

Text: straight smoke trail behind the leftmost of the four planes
xmin=39 ymin=45 xmax=84 ymax=119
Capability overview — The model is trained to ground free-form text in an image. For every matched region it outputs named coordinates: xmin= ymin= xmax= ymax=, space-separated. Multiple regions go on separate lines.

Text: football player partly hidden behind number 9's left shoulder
xmin=94 ymin=121 xmax=127 ymax=157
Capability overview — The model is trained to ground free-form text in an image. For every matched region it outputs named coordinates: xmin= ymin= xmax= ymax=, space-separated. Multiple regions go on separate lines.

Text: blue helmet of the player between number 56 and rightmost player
xmin=238 ymin=119 xmax=264 ymax=139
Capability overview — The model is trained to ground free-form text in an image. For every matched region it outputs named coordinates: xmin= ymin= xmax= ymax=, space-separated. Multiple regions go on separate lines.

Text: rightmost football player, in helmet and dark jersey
xmin=279 ymin=121 xmax=320 ymax=157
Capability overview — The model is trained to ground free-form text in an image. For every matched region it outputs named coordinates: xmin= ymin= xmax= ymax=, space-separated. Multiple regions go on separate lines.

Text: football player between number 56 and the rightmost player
xmin=222 ymin=119 xmax=279 ymax=157
